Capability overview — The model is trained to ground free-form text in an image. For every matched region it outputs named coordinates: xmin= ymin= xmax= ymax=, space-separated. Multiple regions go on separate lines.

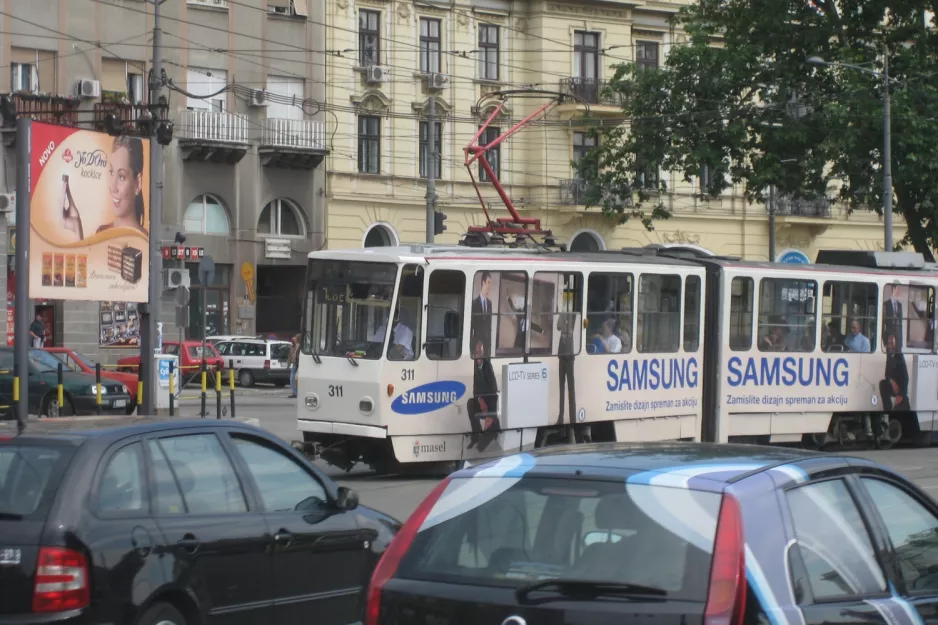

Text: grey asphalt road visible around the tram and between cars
xmin=180 ymin=387 xmax=938 ymax=520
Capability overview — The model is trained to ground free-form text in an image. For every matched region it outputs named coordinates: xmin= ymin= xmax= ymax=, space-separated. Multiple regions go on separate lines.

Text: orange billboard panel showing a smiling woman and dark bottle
xmin=29 ymin=122 xmax=150 ymax=302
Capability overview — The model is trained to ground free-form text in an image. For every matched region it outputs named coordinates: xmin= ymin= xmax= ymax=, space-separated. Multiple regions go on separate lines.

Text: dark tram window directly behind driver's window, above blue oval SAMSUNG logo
xmin=426 ymin=269 xmax=466 ymax=360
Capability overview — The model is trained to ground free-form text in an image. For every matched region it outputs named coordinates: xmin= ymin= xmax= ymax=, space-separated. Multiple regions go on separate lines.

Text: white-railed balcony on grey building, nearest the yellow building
xmin=258 ymin=117 xmax=328 ymax=169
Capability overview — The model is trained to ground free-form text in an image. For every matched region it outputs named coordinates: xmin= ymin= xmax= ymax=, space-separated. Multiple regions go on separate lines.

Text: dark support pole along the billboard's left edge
xmin=13 ymin=117 xmax=32 ymax=432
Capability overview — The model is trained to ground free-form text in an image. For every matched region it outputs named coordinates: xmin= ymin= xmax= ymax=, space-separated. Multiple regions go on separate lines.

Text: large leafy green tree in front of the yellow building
xmin=575 ymin=0 xmax=938 ymax=260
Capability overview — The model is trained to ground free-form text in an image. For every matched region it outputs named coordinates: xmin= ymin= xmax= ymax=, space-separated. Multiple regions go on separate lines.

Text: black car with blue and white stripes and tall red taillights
xmin=364 ymin=439 xmax=938 ymax=625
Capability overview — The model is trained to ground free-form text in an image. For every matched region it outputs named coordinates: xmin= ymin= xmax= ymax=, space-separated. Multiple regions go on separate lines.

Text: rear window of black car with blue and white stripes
xmin=398 ymin=477 xmax=721 ymax=601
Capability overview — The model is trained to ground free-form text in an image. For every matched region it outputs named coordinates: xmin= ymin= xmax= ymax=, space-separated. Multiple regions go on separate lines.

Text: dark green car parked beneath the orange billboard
xmin=0 ymin=347 xmax=131 ymax=416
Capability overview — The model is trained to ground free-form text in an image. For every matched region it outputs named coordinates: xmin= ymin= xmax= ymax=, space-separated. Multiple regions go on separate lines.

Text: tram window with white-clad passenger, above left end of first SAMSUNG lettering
xmin=586 ymin=273 xmax=634 ymax=354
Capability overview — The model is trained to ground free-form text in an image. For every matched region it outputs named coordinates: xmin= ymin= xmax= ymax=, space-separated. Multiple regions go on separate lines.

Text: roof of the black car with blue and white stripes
xmin=453 ymin=442 xmax=840 ymax=485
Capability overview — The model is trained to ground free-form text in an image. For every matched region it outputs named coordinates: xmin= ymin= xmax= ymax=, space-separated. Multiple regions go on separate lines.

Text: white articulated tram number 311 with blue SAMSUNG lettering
xmin=298 ymin=245 xmax=938 ymax=469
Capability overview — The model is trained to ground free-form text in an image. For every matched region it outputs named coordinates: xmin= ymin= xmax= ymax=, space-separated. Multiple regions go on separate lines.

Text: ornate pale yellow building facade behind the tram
xmin=325 ymin=0 xmax=904 ymax=260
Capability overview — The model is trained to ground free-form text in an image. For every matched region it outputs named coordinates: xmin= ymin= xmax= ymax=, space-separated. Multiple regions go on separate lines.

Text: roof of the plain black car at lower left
xmin=0 ymin=416 xmax=260 ymax=444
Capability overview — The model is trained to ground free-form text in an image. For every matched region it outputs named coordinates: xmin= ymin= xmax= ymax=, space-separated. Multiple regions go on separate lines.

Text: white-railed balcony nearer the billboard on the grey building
xmin=175 ymin=110 xmax=250 ymax=164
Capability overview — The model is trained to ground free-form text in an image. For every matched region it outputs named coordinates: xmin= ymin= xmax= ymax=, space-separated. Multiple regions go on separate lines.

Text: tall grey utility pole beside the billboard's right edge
xmin=138 ymin=0 xmax=165 ymax=415
